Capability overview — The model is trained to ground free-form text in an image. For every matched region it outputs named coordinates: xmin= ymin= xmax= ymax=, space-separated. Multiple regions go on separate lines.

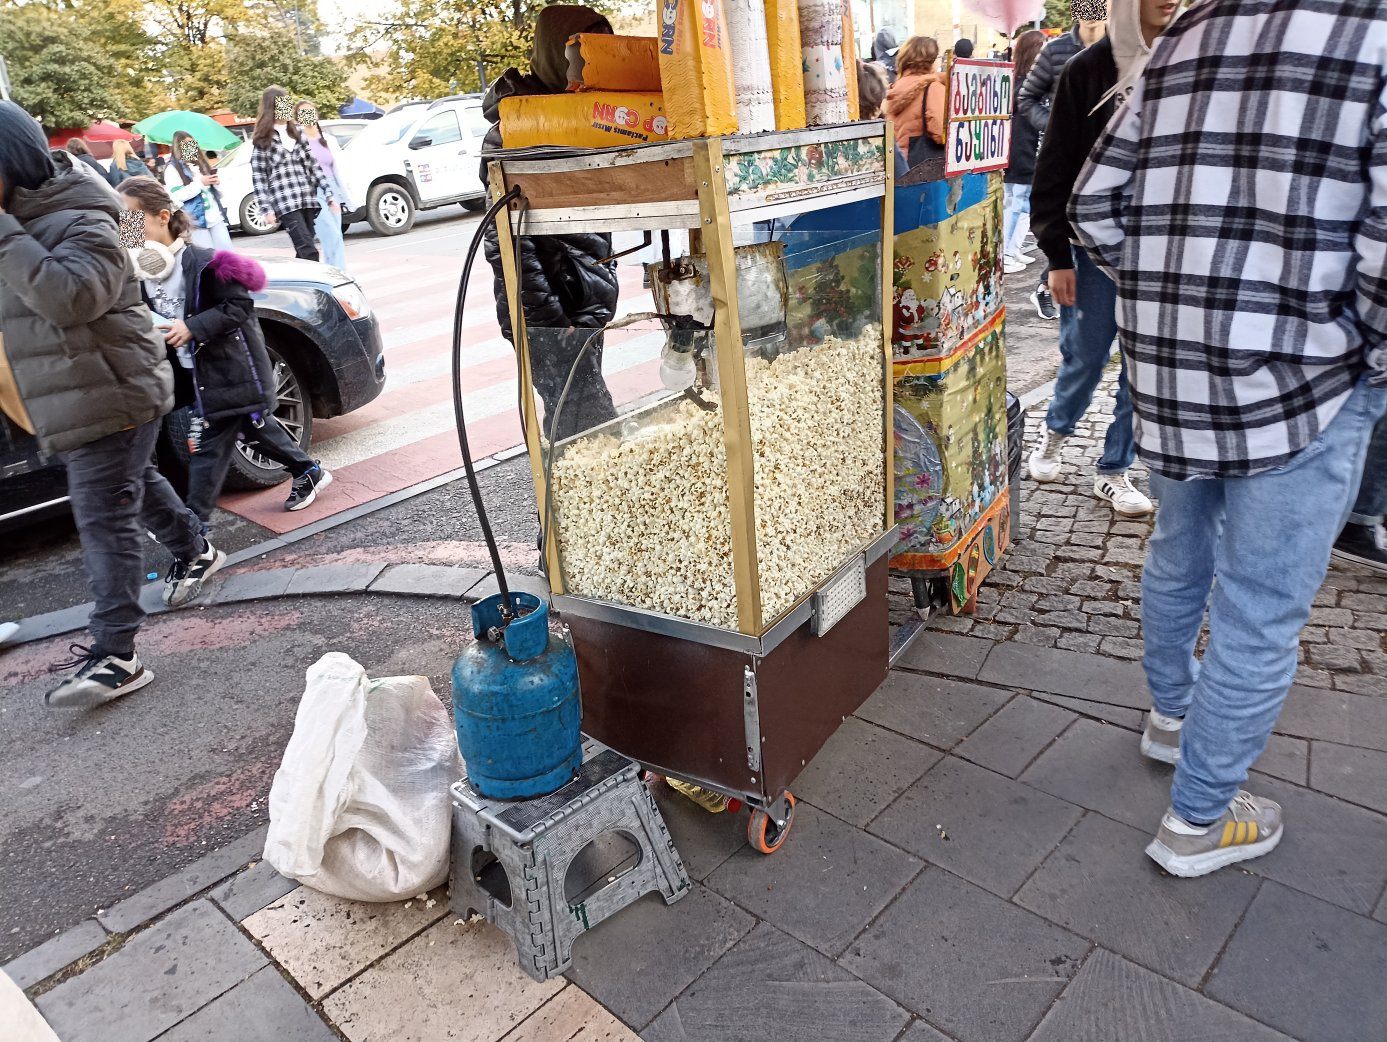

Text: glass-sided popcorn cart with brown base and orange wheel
xmin=490 ymin=122 xmax=896 ymax=853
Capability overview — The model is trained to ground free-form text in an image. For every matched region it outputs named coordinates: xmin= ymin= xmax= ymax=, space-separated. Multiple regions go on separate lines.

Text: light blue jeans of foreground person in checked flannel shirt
xmin=1142 ymin=383 xmax=1387 ymax=823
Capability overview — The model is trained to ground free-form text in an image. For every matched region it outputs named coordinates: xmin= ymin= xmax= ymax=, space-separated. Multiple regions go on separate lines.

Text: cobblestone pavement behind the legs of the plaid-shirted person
xmin=896 ymin=369 xmax=1387 ymax=697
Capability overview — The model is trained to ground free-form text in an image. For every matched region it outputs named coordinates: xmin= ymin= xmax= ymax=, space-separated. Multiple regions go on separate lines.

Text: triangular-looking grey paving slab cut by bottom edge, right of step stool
xmin=642 ymin=923 xmax=908 ymax=1042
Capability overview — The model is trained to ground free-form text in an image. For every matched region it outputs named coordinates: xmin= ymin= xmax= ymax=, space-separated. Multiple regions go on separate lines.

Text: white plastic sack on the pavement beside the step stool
xmin=265 ymin=652 xmax=462 ymax=900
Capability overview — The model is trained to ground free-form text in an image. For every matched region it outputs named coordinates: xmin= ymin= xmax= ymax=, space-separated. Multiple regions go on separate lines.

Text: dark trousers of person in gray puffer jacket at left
xmin=62 ymin=420 xmax=203 ymax=658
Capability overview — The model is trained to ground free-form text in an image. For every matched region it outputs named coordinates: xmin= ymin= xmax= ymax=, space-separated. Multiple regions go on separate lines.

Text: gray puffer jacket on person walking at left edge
xmin=0 ymin=158 xmax=173 ymax=452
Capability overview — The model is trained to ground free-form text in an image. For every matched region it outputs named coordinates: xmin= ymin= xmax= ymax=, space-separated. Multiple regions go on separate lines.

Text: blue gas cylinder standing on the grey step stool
xmin=452 ymin=592 xmax=583 ymax=799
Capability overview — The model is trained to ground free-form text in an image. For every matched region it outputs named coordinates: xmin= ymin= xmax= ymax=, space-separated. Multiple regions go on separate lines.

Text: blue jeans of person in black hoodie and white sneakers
xmin=1044 ymin=247 xmax=1136 ymax=475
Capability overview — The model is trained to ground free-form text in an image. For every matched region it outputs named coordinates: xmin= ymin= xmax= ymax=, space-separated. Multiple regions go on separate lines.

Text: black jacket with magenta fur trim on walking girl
xmin=150 ymin=246 xmax=275 ymax=420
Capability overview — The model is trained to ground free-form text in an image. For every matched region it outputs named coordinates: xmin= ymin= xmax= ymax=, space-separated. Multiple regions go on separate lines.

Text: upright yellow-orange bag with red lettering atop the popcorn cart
xmin=660 ymin=0 xmax=736 ymax=137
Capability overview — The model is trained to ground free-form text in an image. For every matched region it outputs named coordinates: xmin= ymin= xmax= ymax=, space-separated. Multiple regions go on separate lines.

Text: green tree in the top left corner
xmin=0 ymin=6 xmax=117 ymax=130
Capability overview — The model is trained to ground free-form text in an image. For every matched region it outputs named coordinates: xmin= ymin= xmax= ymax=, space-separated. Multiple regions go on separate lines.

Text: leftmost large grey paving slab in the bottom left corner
xmin=36 ymin=900 xmax=266 ymax=1042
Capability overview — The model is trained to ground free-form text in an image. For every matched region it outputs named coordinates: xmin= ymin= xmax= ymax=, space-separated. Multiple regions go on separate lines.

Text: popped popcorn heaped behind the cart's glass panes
xmin=553 ymin=325 xmax=885 ymax=630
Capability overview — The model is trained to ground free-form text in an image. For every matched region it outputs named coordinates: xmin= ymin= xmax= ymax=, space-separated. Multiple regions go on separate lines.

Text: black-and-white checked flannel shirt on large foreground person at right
xmin=1071 ymin=0 xmax=1387 ymax=479
